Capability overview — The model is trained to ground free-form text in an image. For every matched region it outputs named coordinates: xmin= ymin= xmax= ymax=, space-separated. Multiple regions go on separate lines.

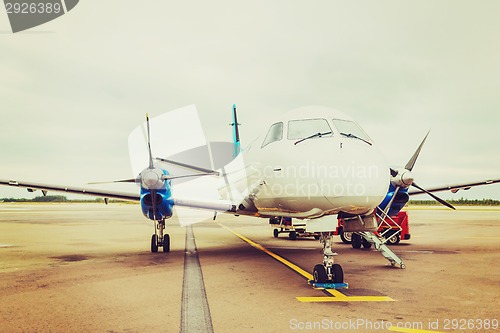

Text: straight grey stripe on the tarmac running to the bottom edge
xmin=181 ymin=226 xmax=214 ymax=333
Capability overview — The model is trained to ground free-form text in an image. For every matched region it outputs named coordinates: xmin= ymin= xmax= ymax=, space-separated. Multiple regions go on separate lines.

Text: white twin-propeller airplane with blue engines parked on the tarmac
xmin=0 ymin=105 xmax=500 ymax=283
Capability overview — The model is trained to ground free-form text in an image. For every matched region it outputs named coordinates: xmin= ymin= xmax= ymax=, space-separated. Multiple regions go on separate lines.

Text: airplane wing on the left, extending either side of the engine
xmin=0 ymin=179 xmax=236 ymax=212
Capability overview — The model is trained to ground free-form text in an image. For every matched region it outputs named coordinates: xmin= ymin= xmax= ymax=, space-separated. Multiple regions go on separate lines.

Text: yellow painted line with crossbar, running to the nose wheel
xmin=217 ymin=223 xmax=395 ymax=303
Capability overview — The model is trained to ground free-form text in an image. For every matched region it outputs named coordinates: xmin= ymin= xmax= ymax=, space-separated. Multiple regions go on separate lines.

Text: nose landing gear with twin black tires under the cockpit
xmin=313 ymin=232 xmax=344 ymax=283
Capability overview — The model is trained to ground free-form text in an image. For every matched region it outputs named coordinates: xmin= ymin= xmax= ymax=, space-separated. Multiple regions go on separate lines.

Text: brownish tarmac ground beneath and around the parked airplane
xmin=0 ymin=203 xmax=500 ymax=333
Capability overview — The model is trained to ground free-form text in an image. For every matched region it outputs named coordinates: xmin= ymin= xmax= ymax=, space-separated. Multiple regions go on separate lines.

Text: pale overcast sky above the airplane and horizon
xmin=0 ymin=0 xmax=500 ymax=199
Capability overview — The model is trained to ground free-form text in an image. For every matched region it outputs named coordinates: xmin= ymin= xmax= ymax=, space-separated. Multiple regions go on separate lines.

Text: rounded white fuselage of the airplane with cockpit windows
xmin=223 ymin=107 xmax=390 ymax=218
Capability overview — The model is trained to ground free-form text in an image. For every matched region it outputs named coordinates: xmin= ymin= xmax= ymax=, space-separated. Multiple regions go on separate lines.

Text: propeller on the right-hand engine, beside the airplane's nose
xmin=385 ymin=131 xmax=455 ymax=210
